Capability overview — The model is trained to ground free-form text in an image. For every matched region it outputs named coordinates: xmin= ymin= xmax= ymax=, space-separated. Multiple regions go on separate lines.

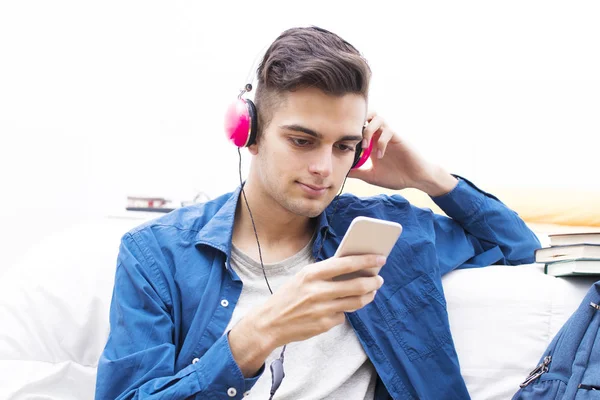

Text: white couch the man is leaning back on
xmin=0 ymin=214 xmax=594 ymax=400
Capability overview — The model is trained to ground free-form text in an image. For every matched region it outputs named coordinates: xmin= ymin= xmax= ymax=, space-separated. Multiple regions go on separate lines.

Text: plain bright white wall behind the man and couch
xmin=0 ymin=0 xmax=600 ymax=268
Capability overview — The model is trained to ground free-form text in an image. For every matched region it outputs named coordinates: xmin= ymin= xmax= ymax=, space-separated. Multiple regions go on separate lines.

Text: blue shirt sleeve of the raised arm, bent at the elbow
xmin=432 ymin=176 xmax=541 ymax=274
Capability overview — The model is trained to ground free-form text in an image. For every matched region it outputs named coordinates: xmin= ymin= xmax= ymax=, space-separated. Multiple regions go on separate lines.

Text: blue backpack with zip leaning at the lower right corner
xmin=513 ymin=281 xmax=600 ymax=400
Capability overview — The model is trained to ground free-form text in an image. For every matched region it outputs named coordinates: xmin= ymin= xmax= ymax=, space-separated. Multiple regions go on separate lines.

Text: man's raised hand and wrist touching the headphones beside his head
xmin=348 ymin=111 xmax=458 ymax=197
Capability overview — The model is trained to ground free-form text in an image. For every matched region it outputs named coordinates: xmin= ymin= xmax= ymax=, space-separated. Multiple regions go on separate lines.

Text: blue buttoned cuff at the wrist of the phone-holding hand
xmin=192 ymin=334 xmax=265 ymax=399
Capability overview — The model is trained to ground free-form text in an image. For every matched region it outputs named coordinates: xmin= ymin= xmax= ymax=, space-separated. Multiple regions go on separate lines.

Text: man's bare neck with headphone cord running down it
xmin=232 ymin=178 xmax=316 ymax=263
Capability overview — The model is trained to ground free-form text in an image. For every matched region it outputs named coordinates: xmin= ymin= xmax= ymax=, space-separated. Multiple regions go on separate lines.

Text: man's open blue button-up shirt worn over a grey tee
xmin=96 ymin=179 xmax=540 ymax=400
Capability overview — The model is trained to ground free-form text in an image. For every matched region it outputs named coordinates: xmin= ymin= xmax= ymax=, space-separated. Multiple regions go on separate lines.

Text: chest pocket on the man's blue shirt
xmin=382 ymin=274 xmax=452 ymax=361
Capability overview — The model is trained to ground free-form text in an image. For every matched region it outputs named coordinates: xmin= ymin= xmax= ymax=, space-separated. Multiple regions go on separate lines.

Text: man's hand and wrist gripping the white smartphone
xmin=229 ymin=255 xmax=385 ymax=377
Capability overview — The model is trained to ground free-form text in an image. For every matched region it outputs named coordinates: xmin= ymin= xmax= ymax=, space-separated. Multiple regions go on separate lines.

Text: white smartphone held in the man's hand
xmin=334 ymin=217 xmax=402 ymax=281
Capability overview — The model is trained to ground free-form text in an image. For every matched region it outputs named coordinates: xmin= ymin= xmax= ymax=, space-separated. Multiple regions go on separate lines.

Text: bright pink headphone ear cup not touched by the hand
xmin=225 ymin=99 xmax=257 ymax=147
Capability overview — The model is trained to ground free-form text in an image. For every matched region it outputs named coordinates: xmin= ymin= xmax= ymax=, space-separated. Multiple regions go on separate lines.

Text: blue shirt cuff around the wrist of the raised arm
xmin=431 ymin=174 xmax=500 ymax=221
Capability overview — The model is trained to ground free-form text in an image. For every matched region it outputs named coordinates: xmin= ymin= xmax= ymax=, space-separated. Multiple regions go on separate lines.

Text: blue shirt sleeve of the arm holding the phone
xmin=96 ymin=234 xmax=264 ymax=400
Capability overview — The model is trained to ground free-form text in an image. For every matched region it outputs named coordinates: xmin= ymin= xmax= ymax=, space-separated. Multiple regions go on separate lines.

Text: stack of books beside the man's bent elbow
xmin=535 ymin=232 xmax=600 ymax=276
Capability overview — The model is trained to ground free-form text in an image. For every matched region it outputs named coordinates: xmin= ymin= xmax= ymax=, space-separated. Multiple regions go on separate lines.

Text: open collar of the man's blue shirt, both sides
xmin=195 ymin=186 xmax=337 ymax=264
